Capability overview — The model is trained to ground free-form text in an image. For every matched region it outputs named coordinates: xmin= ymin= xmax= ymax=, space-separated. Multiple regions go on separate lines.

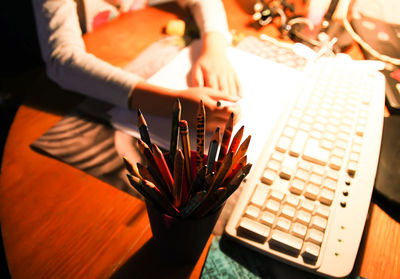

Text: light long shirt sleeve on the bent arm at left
xmin=32 ymin=0 xmax=142 ymax=107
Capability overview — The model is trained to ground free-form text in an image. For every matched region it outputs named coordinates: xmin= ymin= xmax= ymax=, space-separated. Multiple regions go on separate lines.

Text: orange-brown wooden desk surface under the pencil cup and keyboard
xmin=0 ymin=0 xmax=400 ymax=278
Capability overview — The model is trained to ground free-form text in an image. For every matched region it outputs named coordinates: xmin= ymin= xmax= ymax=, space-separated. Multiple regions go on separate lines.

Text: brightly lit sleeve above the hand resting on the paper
xmin=176 ymin=0 xmax=232 ymax=43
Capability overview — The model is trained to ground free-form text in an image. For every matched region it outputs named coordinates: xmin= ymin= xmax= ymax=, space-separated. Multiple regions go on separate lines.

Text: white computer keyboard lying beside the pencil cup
xmin=226 ymin=55 xmax=385 ymax=277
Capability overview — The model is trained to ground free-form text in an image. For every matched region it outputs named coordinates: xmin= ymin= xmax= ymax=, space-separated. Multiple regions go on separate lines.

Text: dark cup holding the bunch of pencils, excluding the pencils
xmin=146 ymin=199 xmax=222 ymax=264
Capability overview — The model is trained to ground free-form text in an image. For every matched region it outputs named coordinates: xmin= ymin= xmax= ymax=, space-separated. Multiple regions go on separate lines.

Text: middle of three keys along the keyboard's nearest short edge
xmin=269 ymin=230 xmax=303 ymax=256
